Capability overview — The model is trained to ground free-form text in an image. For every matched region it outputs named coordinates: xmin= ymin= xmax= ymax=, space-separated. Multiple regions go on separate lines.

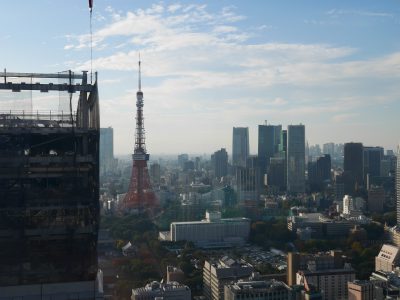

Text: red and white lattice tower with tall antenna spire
xmin=120 ymin=58 xmax=158 ymax=215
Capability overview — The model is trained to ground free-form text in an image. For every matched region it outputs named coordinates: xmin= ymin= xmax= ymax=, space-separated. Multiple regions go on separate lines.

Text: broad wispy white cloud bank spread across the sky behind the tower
xmin=61 ymin=2 xmax=400 ymax=152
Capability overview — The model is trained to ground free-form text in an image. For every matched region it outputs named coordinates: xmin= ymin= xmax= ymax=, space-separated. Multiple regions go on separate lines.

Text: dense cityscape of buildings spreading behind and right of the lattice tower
xmin=96 ymin=116 xmax=400 ymax=299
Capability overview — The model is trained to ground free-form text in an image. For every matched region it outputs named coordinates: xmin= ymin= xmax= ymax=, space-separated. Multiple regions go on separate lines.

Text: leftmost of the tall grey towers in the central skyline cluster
xmin=232 ymin=127 xmax=250 ymax=167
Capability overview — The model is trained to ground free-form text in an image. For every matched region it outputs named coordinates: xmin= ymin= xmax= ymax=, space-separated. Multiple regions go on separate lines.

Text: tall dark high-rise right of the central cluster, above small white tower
xmin=343 ymin=143 xmax=364 ymax=195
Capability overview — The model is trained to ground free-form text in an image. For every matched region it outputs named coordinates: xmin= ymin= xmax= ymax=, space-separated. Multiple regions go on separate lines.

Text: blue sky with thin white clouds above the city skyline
xmin=0 ymin=0 xmax=400 ymax=154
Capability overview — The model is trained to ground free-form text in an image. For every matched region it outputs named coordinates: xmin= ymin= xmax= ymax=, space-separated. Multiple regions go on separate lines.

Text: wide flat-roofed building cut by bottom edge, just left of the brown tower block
xmin=224 ymin=280 xmax=292 ymax=300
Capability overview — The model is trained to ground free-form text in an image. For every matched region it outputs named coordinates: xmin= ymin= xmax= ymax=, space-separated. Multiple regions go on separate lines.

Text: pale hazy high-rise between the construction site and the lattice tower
xmin=100 ymin=127 xmax=114 ymax=174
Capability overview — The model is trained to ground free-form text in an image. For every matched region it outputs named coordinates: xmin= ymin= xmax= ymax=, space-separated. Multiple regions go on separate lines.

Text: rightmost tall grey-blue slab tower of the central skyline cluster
xmin=287 ymin=125 xmax=305 ymax=193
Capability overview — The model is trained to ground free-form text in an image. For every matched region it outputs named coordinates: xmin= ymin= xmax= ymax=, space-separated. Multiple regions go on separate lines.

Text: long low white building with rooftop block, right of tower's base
xmin=163 ymin=212 xmax=250 ymax=247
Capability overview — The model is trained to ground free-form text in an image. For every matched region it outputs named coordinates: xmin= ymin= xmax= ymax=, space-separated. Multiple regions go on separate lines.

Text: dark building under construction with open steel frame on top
xmin=0 ymin=71 xmax=101 ymax=299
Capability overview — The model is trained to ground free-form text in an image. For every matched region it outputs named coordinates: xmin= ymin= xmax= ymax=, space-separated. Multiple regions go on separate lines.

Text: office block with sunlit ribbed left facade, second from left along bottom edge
xmin=203 ymin=256 xmax=254 ymax=300
